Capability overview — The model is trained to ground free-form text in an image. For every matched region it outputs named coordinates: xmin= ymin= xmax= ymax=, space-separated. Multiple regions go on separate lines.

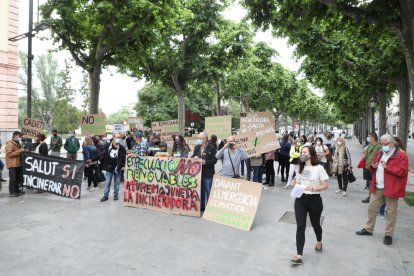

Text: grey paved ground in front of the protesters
xmin=0 ymin=140 xmax=414 ymax=276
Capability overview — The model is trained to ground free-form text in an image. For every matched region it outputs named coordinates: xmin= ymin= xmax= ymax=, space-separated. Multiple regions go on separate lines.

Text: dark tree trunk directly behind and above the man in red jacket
xmin=397 ymin=74 xmax=411 ymax=145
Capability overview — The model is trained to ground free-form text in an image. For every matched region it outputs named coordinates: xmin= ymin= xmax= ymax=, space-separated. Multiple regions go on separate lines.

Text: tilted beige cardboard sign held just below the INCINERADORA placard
xmin=234 ymin=128 xmax=280 ymax=157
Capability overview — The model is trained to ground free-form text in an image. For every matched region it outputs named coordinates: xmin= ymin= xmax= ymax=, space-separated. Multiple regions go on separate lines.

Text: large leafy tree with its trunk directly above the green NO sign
xmin=41 ymin=0 xmax=180 ymax=113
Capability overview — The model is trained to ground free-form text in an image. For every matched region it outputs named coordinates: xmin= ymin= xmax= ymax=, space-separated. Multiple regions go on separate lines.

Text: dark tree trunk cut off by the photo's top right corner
xmin=398 ymin=0 xmax=414 ymax=98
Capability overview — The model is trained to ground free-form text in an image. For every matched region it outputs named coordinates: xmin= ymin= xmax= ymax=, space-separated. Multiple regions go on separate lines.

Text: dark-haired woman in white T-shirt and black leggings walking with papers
xmin=290 ymin=147 xmax=329 ymax=265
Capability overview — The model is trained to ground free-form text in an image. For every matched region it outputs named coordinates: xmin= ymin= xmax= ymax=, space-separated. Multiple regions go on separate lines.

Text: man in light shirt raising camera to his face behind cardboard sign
xmin=216 ymin=136 xmax=249 ymax=178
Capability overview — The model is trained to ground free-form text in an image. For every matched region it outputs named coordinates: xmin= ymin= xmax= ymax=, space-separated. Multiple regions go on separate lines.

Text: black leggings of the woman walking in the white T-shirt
xmin=295 ymin=194 xmax=323 ymax=255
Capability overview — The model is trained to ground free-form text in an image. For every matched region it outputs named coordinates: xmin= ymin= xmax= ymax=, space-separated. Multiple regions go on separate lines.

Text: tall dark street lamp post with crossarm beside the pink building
xmin=9 ymin=0 xmax=49 ymax=118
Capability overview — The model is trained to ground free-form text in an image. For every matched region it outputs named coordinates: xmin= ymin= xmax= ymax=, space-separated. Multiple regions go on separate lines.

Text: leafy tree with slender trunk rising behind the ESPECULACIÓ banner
xmin=124 ymin=0 xmax=231 ymax=133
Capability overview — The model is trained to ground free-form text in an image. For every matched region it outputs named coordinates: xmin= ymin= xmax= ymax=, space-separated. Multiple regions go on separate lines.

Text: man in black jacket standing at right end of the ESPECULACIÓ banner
xmin=191 ymin=132 xmax=217 ymax=211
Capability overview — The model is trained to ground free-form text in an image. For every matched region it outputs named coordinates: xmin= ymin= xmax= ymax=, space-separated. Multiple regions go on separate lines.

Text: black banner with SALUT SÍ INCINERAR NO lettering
xmin=23 ymin=152 xmax=84 ymax=199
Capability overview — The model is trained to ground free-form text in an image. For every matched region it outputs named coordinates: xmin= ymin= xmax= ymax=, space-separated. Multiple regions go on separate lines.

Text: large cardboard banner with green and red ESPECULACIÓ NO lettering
xmin=124 ymin=157 xmax=202 ymax=217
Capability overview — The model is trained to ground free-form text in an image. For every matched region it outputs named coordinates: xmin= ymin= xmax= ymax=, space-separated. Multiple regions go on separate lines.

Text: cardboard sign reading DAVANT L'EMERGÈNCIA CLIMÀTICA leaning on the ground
xmin=203 ymin=175 xmax=262 ymax=231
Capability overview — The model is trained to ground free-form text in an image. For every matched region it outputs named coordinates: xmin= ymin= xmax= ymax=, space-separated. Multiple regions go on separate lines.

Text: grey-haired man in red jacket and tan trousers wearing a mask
xmin=355 ymin=134 xmax=408 ymax=245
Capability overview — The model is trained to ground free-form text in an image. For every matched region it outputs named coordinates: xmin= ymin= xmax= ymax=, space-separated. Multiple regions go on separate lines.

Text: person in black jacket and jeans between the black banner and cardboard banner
xmin=101 ymin=134 xmax=126 ymax=202
